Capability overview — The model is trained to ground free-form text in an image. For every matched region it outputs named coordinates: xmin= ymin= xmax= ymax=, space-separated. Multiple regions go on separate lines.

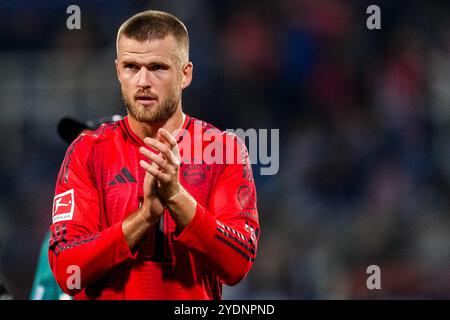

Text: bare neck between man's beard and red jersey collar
xmin=128 ymin=108 xmax=186 ymax=140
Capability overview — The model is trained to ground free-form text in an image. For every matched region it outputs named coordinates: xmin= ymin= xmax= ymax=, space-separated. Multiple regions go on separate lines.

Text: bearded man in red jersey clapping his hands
xmin=49 ymin=11 xmax=259 ymax=299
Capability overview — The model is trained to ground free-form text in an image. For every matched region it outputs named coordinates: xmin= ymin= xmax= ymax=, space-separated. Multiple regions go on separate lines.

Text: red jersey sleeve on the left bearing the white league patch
xmin=48 ymin=136 xmax=133 ymax=295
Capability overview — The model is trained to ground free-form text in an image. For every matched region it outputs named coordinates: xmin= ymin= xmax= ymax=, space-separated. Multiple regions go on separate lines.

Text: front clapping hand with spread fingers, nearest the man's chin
xmin=139 ymin=128 xmax=182 ymax=203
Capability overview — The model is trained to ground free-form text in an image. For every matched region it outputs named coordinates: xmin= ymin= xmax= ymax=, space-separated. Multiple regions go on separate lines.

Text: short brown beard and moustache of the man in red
xmin=121 ymin=89 xmax=181 ymax=123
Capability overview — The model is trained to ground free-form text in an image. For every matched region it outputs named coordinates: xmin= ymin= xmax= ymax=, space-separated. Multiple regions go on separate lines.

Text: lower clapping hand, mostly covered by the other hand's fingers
xmin=142 ymin=163 xmax=164 ymax=223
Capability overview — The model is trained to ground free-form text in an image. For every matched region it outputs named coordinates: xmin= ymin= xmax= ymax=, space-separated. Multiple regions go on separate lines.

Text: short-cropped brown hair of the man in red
xmin=116 ymin=10 xmax=189 ymax=60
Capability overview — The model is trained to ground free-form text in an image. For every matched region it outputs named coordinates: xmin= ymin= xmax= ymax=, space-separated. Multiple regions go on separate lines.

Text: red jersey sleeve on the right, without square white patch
xmin=174 ymin=137 xmax=260 ymax=285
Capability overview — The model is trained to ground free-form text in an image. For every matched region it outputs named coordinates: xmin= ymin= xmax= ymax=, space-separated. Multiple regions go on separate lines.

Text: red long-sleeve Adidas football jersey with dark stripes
xmin=48 ymin=116 xmax=259 ymax=299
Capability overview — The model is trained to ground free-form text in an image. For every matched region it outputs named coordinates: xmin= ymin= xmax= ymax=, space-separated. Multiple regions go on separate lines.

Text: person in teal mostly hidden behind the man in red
xmin=30 ymin=115 xmax=122 ymax=300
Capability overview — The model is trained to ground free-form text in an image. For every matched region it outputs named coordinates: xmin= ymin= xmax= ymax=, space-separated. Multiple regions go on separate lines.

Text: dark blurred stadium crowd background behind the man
xmin=0 ymin=0 xmax=450 ymax=299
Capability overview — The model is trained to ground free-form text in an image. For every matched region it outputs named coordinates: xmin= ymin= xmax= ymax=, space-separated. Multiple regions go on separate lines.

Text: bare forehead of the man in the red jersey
xmin=117 ymin=35 xmax=180 ymax=62
